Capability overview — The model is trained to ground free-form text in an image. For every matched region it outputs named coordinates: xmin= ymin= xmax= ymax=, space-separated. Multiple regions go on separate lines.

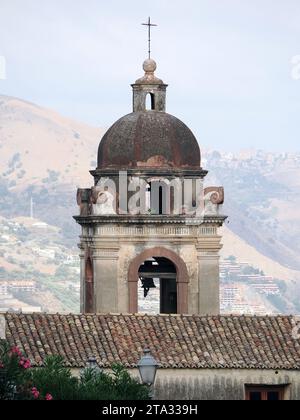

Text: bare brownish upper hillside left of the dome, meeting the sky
xmin=0 ymin=96 xmax=103 ymax=236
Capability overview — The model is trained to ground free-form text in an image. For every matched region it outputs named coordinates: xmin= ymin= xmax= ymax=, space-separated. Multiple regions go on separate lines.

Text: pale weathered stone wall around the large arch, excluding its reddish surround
xmin=81 ymin=223 xmax=221 ymax=315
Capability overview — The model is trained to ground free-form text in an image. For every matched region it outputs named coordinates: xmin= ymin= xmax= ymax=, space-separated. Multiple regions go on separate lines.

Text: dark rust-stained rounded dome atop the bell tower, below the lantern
xmin=98 ymin=111 xmax=201 ymax=169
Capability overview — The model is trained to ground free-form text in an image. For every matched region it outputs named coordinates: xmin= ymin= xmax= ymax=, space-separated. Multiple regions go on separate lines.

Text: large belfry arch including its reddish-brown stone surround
xmin=128 ymin=247 xmax=189 ymax=314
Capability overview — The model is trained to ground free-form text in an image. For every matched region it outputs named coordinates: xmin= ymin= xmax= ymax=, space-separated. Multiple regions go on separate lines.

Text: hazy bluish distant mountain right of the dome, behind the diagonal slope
xmin=204 ymin=151 xmax=300 ymax=270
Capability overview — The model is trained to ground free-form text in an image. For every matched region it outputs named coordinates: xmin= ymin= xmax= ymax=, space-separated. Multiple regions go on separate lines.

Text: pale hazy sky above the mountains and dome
xmin=0 ymin=0 xmax=300 ymax=151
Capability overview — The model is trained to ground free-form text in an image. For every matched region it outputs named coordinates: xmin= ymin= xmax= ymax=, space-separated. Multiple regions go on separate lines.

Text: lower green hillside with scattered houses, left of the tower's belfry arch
xmin=0 ymin=217 xmax=79 ymax=312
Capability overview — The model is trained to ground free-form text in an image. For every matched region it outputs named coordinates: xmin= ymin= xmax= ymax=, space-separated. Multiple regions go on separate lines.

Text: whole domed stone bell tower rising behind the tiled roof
xmin=75 ymin=59 xmax=225 ymax=315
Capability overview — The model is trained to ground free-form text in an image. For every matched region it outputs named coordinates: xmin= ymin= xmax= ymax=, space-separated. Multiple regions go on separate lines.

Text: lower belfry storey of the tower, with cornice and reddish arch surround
xmin=76 ymin=217 xmax=224 ymax=315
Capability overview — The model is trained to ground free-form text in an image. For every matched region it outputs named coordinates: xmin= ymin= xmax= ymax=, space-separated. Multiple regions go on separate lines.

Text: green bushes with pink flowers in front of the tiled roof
xmin=0 ymin=341 xmax=150 ymax=401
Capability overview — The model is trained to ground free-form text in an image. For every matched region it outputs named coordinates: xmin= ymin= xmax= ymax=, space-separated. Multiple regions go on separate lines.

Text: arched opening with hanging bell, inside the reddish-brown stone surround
xmin=138 ymin=257 xmax=177 ymax=314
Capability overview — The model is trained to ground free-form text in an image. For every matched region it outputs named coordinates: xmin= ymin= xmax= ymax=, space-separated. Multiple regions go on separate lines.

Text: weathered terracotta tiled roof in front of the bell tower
xmin=5 ymin=314 xmax=300 ymax=370
